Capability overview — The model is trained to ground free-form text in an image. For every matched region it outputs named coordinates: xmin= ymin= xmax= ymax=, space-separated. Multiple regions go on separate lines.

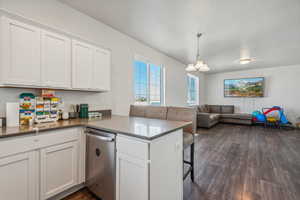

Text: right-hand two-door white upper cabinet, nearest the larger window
xmin=72 ymin=40 xmax=111 ymax=91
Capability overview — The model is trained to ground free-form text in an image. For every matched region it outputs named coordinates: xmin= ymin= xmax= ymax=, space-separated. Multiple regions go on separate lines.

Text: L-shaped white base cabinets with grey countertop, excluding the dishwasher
xmin=0 ymin=116 xmax=191 ymax=200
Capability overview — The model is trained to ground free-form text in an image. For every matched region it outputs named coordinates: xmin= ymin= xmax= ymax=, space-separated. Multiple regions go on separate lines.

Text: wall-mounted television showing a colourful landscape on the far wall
xmin=224 ymin=77 xmax=265 ymax=97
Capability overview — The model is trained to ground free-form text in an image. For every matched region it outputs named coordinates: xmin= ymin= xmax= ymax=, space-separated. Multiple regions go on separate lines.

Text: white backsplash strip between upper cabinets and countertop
xmin=0 ymin=88 xmax=112 ymax=117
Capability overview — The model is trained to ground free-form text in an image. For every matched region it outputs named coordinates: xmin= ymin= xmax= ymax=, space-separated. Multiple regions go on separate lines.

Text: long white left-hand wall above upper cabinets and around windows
xmin=0 ymin=0 xmax=204 ymax=115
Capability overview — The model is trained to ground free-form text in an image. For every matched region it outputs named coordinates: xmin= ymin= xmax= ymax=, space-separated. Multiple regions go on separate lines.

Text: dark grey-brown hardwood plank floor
xmin=65 ymin=124 xmax=300 ymax=200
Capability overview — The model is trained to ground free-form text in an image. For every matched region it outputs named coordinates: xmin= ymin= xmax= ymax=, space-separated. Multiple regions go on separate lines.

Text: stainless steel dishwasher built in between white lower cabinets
xmin=86 ymin=128 xmax=116 ymax=200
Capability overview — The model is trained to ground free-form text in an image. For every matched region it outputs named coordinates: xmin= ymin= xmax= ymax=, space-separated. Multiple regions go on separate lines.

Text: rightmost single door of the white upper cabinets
xmin=93 ymin=48 xmax=111 ymax=91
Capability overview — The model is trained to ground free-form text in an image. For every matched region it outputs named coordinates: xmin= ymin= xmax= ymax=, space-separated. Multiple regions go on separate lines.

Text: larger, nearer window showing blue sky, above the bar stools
xmin=134 ymin=57 xmax=163 ymax=105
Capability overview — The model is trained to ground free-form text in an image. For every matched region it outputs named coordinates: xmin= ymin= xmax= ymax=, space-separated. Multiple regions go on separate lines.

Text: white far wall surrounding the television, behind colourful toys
xmin=205 ymin=65 xmax=300 ymax=122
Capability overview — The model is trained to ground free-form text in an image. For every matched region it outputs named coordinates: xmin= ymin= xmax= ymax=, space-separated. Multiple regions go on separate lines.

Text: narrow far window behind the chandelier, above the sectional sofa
xmin=187 ymin=74 xmax=199 ymax=105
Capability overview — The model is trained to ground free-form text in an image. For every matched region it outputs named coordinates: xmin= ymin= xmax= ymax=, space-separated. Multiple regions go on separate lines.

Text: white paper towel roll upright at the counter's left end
xmin=6 ymin=103 xmax=20 ymax=127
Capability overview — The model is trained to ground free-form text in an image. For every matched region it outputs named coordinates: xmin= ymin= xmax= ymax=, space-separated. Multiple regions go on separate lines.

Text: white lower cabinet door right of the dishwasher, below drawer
xmin=116 ymin=153 xmax=149 ymax=200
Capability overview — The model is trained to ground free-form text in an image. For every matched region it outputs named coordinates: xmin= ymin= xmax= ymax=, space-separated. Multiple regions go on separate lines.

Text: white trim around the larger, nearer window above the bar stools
xmin=132 ymin=54 xmax=166 ymax=106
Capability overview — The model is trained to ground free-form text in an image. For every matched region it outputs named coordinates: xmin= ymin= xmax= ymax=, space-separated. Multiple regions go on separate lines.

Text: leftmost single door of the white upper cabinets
xmin=2 ymin=17 xmax=41 ymax=86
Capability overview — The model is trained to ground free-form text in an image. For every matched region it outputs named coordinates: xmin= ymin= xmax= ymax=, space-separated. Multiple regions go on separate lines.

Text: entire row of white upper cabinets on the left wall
xmin=0 ymin=16 xmax=111 ymax=91
